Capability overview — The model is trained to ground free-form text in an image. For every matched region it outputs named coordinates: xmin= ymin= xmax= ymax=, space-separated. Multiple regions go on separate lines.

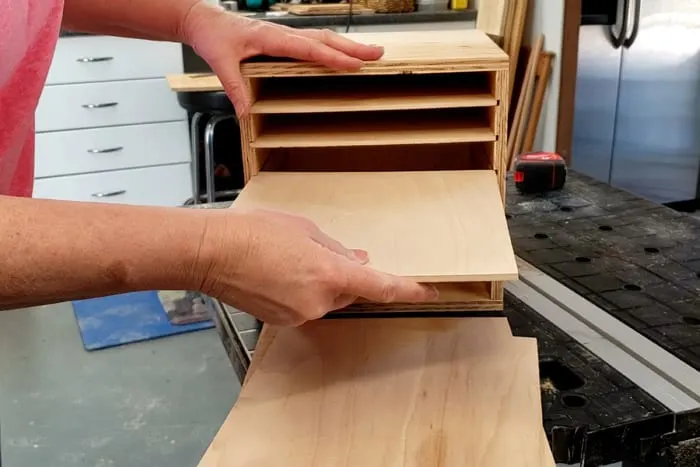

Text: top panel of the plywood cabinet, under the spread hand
xmin=242 ymin=29 xmax=508 ymax=78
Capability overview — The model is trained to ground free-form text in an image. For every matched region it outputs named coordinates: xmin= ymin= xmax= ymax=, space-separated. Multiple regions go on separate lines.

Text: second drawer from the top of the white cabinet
xmin=36 ymin=78 xmax=186 ymax=132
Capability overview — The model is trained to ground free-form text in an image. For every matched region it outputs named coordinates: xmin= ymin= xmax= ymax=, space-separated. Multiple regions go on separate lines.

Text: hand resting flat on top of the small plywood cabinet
xmin=183 ymin=2 xmax=384 ymax=117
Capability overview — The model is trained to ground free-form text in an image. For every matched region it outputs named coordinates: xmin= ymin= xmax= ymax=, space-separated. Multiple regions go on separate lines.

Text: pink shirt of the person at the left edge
xmin=0 ymin=0 xmax=63 ymax=196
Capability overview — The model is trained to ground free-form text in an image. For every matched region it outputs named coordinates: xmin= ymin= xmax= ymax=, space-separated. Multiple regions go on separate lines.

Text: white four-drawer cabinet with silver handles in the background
xmin=34 ymin=36 xmax=192 ymax=206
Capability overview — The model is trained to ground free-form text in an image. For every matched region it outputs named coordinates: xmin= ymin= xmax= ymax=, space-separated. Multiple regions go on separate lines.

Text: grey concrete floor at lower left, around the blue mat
xmin=0 ymin=304 xmax=240 ymax=467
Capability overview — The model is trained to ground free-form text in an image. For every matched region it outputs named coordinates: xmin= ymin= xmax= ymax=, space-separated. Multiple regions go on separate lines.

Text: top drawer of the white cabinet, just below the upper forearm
xmin=46 ymin=36 xmax=183 ymax=84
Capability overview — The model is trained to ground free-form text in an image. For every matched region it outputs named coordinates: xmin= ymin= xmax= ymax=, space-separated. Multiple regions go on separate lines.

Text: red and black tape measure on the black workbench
xmin=513 ymin=152 xmax=566 ymax=193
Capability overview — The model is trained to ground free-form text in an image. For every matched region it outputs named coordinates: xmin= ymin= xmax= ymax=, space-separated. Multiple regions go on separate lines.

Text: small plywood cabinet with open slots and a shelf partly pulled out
xmin=235 ymin=30 xmax=517 ymax=310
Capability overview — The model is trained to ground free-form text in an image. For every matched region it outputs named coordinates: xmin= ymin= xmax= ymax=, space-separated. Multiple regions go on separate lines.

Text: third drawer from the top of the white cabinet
xmin=35 ymin=120 xmax=190 ymax=178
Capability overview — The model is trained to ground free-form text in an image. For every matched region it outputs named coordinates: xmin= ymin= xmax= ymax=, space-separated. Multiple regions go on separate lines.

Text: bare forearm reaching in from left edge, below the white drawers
xmin=0 ymin=196 xmax=213 ymax=309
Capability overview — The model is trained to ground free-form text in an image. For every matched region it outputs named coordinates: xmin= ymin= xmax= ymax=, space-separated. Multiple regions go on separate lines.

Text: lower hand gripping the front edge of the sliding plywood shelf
xmin=197 ymin=207 xmax=437 ymax=326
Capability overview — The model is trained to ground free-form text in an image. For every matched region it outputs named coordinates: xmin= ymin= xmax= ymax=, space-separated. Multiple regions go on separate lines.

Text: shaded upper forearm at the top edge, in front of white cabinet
xmin=63 ymin=0 xmax=216 ymax=43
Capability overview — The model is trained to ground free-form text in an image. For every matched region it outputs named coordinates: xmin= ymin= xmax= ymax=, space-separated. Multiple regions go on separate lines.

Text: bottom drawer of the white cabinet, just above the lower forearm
xmin=34 ymin=164 xmax=192 ymax=206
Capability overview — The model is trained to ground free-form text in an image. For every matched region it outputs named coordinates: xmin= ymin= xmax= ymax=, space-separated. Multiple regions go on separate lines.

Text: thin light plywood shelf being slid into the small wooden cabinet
xmin=234 ymin=170 xmax=517 ymax=282
